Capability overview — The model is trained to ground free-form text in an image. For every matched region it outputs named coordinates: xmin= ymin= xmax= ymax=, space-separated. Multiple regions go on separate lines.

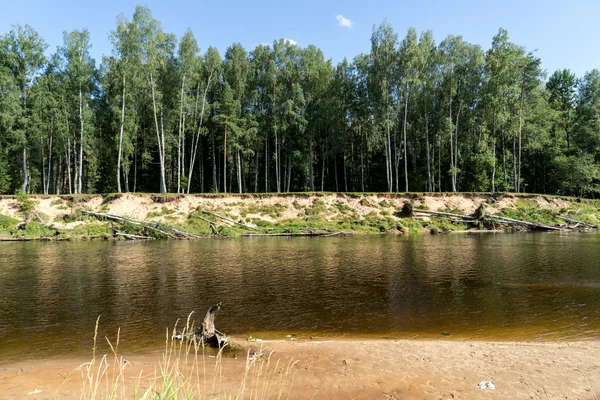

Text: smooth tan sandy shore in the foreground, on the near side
xmin=0 ymin=340 xmax=600 ymax=400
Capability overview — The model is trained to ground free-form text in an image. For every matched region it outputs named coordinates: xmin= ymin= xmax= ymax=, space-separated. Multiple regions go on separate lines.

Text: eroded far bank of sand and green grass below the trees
xmin=0 ymin=193 xmax=600 ymax=238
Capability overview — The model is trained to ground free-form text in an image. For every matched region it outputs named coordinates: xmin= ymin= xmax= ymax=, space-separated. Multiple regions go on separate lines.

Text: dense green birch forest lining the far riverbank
xmin=0 ymin=6 xmax=600 ymax=198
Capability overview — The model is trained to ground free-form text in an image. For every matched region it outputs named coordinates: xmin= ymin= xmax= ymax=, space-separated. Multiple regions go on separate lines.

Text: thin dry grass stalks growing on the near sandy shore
xmin=67 ymin=313 xmax=297 ymax=400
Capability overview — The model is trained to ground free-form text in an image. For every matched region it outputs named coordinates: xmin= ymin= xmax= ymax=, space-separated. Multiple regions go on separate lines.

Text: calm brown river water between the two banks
xmin=0 ymin=233 xmax=600 ymax=362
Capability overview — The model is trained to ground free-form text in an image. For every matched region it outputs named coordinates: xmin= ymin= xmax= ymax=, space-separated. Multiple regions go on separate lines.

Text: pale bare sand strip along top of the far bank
xmin=0 ymin=193 xmax=577 ymax=229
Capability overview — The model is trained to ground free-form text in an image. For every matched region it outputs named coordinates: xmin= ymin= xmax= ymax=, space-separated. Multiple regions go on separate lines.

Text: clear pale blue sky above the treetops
xmin=0 ymin=0 xmax=600 ymax=76
